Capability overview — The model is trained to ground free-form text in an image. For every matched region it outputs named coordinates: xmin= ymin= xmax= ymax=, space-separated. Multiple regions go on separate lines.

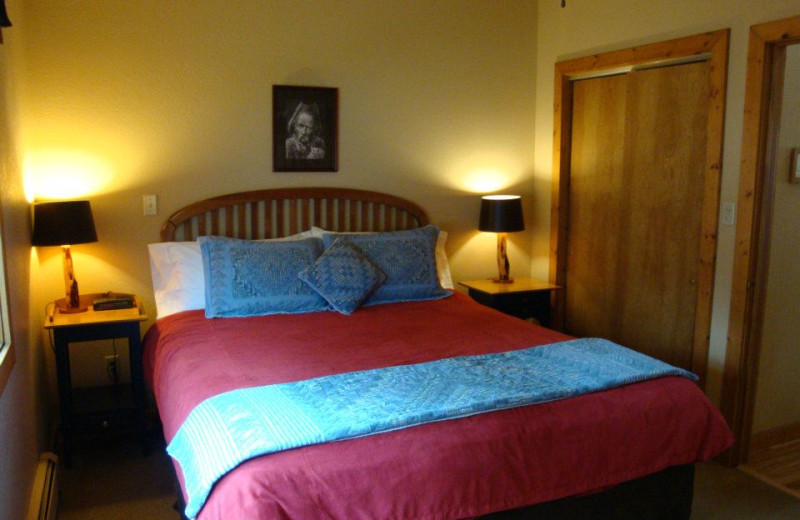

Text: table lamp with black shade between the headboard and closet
xmin=478 ymin=195 xmax=525 ymax=283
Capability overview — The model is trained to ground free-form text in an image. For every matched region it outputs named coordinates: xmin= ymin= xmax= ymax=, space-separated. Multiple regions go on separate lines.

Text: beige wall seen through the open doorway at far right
xmin=753 ymin=45 xmax=800 ymax=433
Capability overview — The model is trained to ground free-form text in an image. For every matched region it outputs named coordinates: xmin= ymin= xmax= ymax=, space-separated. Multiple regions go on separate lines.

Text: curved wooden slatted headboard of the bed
xmin=161 ymin=188 xmax=428 ymax=242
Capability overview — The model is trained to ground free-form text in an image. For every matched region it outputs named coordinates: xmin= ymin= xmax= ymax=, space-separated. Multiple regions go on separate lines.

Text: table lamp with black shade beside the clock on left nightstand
xmin=31 ymin=200 xmax=97 ymax=313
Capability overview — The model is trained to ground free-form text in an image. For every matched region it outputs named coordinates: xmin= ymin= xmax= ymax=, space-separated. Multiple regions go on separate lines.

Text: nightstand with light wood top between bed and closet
xmin=458 ymin=278 xmax=560 ymax=327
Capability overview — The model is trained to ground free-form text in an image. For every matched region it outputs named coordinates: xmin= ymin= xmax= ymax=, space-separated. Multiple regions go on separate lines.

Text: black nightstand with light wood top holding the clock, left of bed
xmin=44 ymin=293 xmax=147 ymax=467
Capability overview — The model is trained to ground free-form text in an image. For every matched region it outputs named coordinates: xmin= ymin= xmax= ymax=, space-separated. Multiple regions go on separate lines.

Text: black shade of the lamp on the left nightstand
xmin=31 ymin=200 xmax=97 ymax=246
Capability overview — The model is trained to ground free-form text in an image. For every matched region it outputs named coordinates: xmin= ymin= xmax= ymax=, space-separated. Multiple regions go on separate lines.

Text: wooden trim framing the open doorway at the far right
xmin=720 ymin=17 xmax=800 ymax=465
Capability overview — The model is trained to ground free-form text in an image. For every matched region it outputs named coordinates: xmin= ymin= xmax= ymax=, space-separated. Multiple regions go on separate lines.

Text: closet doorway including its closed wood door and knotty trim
xmin=550 ymin=30 xmax=728 ymax=384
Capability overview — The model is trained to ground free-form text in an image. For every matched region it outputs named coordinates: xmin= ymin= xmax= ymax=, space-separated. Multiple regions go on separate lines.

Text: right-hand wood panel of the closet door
xmin=620 ymin=62 xmax=709 ymax=368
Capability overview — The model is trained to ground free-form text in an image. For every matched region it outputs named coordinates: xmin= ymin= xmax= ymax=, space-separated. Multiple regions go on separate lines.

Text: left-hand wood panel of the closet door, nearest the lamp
xmin=565 ymin=76 xmax=627 ymax=337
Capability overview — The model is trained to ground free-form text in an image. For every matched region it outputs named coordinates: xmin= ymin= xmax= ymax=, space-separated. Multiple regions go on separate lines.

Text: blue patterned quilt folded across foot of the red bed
xmin=167 ymin=338 xmax=697 ymax=518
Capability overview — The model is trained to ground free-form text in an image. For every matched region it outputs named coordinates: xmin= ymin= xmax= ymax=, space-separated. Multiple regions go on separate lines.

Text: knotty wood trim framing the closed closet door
xmin=550 ymin=29 xmax=730 ymax=385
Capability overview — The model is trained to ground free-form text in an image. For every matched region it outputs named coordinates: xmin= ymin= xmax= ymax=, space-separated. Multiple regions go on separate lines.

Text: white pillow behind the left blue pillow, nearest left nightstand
xmin=147 ymin=231 xmax=315 ymax=318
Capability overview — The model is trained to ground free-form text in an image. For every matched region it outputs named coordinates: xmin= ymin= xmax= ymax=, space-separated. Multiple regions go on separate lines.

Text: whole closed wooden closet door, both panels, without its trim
xmin=565 ymin=62 xmax=709 ymax=368
